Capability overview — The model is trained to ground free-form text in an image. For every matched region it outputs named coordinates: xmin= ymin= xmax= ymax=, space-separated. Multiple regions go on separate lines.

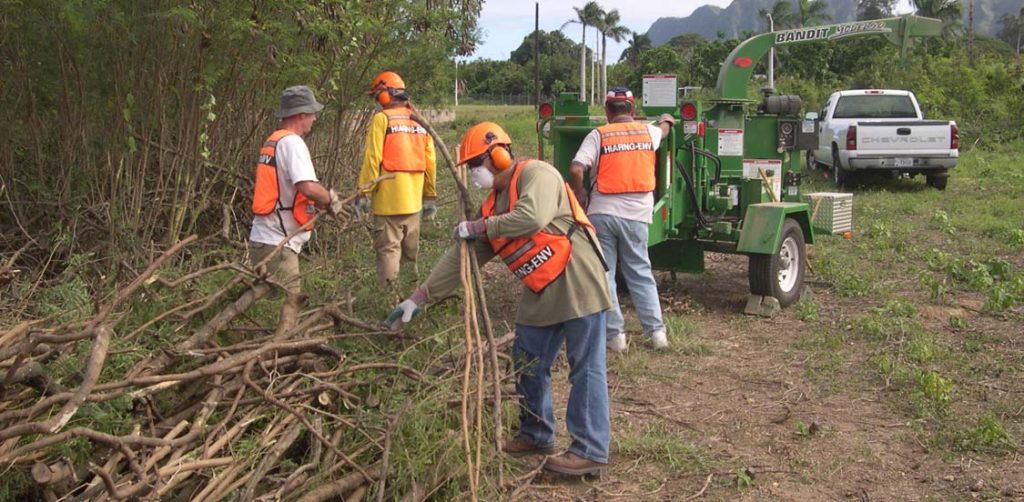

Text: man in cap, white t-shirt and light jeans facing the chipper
xmin=569 ymin=87 xmax=676 ymax=352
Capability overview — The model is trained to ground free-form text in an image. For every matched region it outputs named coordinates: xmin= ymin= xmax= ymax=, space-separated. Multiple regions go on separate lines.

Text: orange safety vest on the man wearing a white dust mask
xmin=480 ymin=161 xmax=603 ymax=294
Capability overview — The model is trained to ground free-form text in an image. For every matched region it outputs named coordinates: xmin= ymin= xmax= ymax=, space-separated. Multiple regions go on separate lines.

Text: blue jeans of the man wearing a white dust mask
xmin=512 ymin=311 xmax=610 ymax=463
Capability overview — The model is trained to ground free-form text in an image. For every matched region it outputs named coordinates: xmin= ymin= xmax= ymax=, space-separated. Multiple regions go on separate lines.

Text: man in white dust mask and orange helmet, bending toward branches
xmin=387 ymin=122 xmax=611 ymax=475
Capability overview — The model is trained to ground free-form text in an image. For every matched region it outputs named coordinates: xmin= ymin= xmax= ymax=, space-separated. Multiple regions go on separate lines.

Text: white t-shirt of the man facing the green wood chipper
xmin=572 ymin=124 xmax=662 ymax=223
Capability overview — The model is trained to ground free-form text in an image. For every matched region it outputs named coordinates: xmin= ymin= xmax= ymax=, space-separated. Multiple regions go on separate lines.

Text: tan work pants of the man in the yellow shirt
xmin=374 ymin=212 xmax=420 ymax=287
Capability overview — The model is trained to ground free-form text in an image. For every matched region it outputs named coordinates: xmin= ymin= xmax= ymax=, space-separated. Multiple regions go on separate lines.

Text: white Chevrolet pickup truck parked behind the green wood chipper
xmin=805 ymin=89 xmax=959 ymax=190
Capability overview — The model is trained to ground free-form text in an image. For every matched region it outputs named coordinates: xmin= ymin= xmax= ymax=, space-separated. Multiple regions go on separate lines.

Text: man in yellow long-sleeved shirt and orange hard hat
xmin=355 ymin=72 xmax=437 ymax=288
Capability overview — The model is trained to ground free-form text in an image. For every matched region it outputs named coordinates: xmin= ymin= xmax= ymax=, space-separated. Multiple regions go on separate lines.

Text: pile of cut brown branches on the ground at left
xmin=0 ymin=230 xmax=512 ymax=501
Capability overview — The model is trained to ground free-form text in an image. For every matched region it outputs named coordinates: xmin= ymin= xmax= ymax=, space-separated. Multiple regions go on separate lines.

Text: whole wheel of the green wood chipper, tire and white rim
xmin=748 ymin=218 xmax=807 ymax=306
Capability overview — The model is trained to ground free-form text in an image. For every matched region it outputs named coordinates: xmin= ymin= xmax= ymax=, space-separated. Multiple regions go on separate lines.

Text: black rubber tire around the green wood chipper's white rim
xmin=746 ymin=218 xmax=807 ymax=306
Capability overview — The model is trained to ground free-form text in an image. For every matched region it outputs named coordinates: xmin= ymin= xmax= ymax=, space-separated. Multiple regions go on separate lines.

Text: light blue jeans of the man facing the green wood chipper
xmin=589 ymin=214 xmax=665 ymax=338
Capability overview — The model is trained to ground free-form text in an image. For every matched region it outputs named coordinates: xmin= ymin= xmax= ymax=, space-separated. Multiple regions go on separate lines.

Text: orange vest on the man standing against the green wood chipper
xmin=596 ymin=121 xmax=655 ymax=194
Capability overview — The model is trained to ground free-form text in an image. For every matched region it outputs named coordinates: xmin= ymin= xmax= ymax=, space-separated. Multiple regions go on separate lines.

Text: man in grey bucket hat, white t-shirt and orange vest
xmin=249 ymin=85 xmax=344 ymax=294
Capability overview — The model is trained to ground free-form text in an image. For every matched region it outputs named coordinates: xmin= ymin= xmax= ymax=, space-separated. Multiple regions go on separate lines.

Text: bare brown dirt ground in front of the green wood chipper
xmin=492 ymin=255 xmax=1024 ymax=501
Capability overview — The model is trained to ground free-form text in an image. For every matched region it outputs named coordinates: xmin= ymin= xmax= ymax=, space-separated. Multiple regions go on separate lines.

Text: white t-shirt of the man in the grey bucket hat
xmin=249 ymin=134 xmax=317 ymax=253
